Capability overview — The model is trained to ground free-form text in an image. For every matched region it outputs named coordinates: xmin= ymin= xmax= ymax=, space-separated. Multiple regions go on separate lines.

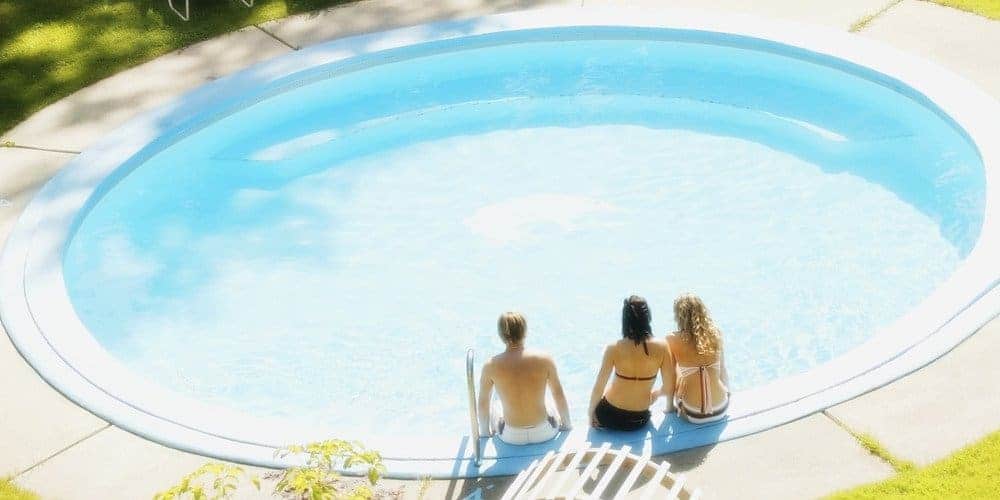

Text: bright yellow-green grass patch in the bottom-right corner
xmin=829 ymin=431 xmax=1000 ymax=500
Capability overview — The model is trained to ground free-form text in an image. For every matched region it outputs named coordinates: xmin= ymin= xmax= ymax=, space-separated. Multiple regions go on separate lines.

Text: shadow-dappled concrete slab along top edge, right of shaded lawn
xmin=261 ymin=0 xmax=581 ymax=48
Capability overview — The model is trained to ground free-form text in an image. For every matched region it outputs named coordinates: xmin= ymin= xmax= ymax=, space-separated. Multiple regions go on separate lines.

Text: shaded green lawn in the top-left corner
xmin=0 ymin=0 xmax=349 ymax=133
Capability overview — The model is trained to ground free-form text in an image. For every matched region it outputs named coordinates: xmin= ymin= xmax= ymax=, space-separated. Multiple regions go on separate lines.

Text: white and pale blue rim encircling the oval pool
xmin=0 ymin=9 xmax=1000 ymax=478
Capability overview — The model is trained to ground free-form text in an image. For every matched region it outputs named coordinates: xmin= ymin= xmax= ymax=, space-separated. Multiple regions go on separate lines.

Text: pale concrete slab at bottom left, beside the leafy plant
xmin=14 ymin=427 xmax=274 ymax=500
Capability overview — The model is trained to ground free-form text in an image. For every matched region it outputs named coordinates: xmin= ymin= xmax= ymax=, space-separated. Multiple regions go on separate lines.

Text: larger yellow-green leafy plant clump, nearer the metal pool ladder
xmin=274 ymin=439 xmax=385 ymax=500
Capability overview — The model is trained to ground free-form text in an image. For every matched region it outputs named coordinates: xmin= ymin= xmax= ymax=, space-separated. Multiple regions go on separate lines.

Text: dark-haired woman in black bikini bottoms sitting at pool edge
xmin=590 ymin=295 xmax=674 ymax=431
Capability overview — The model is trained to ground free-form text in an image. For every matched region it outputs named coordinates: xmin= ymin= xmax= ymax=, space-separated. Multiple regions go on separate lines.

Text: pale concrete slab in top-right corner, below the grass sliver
xmin=861 ymin=0 xmax=1000 ymax=98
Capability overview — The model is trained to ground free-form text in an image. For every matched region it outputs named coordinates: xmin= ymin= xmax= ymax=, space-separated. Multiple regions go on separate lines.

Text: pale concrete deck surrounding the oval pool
xmin=0 ymin=0 xmax=1000 ymax=498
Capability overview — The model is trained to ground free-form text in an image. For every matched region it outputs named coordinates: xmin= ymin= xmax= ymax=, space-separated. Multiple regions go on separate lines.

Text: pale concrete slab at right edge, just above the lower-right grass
xmin=827 ymin=320 xmax=1000 ymax=464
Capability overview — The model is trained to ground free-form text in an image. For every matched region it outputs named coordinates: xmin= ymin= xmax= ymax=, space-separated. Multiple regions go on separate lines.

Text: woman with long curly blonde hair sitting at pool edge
xmin=653 ymin=294 xmax=729 ymax=424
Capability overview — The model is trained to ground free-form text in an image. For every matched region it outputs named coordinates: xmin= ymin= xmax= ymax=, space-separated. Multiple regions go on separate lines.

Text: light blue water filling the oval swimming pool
xmin=64 ymin=36 xmax=985 ymax=438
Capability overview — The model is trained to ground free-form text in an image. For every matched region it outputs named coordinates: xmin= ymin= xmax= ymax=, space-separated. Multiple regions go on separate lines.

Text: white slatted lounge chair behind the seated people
xmin=501 ymin=443 xmax=701 ymax=500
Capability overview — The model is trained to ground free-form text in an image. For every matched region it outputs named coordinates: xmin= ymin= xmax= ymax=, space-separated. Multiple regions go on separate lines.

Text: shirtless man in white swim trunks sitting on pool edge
xmin=479 ymin=312 xmax=572 ymax=444
